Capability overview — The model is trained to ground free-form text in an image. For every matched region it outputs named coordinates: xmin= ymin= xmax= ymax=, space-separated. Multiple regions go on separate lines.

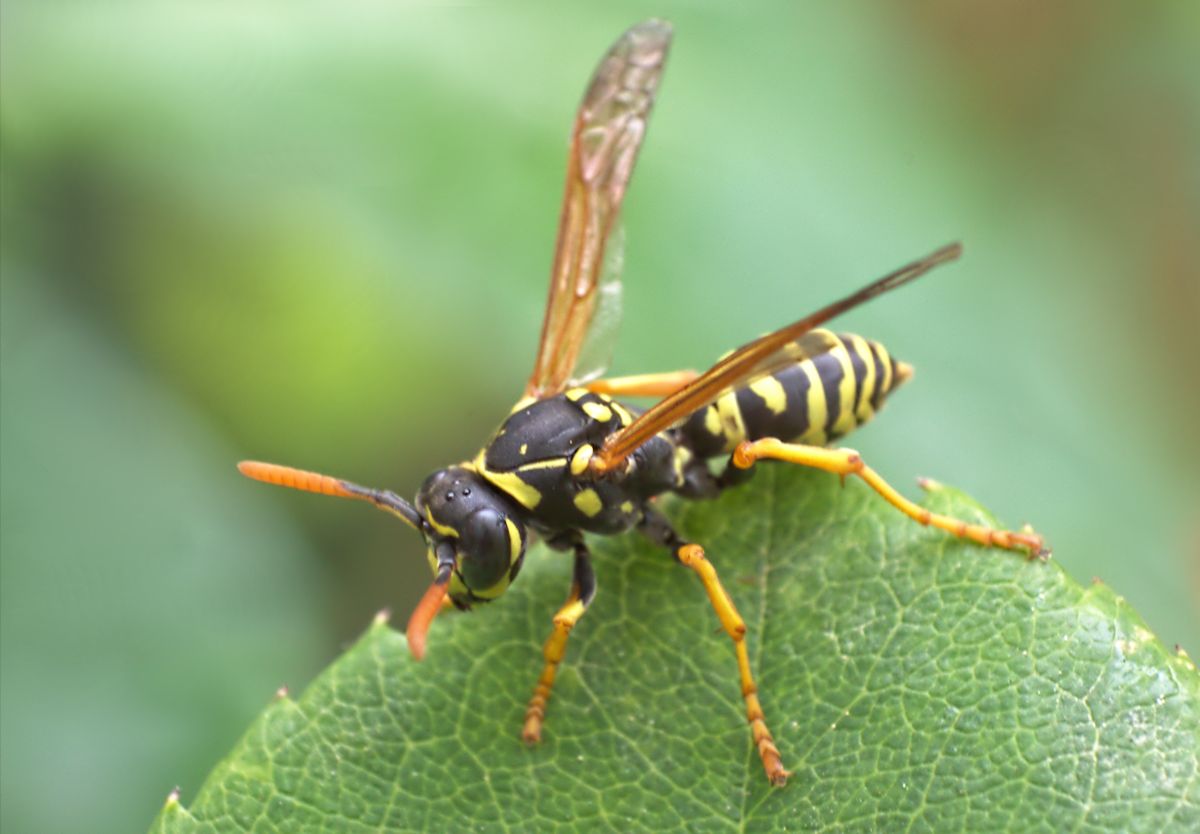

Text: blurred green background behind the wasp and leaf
xmin=0 ymin=0 xmax=1200 ymax=832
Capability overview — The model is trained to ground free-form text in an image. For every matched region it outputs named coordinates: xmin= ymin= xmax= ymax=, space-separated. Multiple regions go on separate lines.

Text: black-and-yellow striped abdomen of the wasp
xmin=679 ymin=330 xmax=912 ymax=457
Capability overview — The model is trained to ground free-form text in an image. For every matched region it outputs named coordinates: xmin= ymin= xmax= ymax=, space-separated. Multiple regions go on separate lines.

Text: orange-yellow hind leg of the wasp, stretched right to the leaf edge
xmin=732 ymin=438 xmax=1050 ymax=558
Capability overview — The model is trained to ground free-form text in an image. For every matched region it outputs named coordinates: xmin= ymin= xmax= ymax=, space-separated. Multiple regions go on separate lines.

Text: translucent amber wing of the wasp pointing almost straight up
xmin=526 ymin=20 xmax=671 ymax=397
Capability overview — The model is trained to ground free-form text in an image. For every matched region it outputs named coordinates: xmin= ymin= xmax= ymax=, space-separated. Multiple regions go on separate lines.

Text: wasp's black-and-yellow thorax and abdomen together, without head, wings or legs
xmin=472 ymin=330 xmax=910 ymax=552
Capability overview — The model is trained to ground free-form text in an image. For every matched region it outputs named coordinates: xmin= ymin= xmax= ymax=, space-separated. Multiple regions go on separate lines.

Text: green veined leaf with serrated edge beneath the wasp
xmin=152 ymin=466 xmax=1200 ymax=832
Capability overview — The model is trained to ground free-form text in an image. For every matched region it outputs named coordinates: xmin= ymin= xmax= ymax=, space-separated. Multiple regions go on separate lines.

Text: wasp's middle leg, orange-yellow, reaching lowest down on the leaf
xmin=641 ymin=511 xmax=792 ymax=787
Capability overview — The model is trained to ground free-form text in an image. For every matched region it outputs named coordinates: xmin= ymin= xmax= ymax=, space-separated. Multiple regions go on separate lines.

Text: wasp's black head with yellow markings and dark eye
xmin=416 ymin=467 xmax=526 ymax=607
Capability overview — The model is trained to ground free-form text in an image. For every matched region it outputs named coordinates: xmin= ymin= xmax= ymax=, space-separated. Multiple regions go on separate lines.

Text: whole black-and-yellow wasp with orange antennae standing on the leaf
xmin=239 ymin=20 xmax=1045 ymax=786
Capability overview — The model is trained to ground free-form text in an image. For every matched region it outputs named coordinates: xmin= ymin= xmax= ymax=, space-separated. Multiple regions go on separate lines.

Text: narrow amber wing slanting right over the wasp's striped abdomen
xmin=590 ymin=244 xmax=962 ymax=474
